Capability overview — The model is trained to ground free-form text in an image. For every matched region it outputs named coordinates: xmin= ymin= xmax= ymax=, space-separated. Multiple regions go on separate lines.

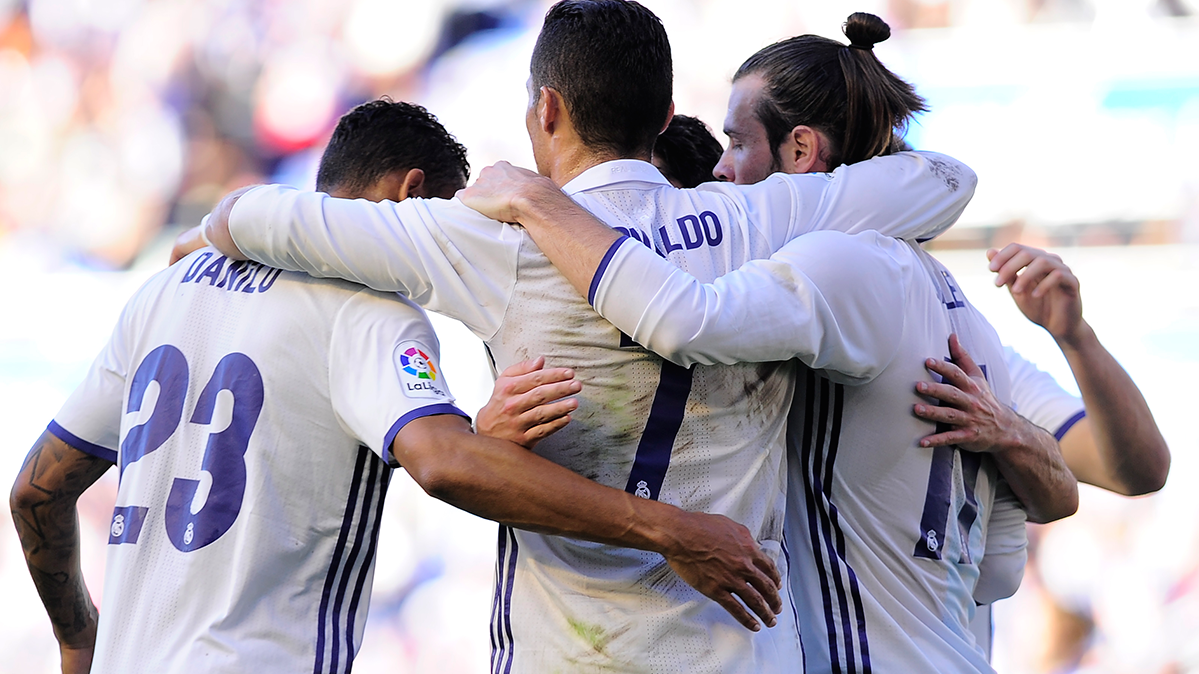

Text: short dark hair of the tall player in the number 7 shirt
xmin=529 ymin=0 xmax=674 ymax=157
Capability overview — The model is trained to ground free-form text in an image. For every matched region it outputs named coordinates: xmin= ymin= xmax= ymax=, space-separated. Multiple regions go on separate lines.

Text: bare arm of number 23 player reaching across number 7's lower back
xmin=392 ymin=415 xmax=782 ymax=631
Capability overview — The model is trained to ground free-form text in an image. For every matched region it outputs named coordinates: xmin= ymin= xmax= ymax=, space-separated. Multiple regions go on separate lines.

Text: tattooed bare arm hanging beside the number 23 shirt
xmin=8 ymin=432 xmax=113 ymax=674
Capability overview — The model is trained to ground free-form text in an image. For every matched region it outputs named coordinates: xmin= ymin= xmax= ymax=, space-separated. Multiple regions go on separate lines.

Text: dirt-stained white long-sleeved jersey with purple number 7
xmin=230 ymin=155 xmax=974 ymax=673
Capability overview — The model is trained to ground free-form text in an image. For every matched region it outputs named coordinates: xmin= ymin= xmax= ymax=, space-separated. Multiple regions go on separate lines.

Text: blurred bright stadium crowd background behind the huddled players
xmin=0 ymin=0 xmax=1199 ymax=674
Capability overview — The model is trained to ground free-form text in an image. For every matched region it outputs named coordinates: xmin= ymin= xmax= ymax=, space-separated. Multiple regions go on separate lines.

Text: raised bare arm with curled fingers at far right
xmin=987 ymin=243 xmax=1170 ymax=495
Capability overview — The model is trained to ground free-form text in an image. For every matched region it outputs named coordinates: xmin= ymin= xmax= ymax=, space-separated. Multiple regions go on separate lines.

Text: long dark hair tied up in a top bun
xmin=733 ymin=12 xmax=928 ymax=167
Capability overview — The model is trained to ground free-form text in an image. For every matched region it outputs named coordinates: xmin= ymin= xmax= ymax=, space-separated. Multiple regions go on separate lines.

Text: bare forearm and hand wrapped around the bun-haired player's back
xmin=915 ymin=335 xmax=1078 ymax=524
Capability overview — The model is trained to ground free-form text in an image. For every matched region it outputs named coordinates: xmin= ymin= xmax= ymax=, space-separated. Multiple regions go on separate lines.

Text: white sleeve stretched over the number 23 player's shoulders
xmin=229 ymin=185 xmax=524 ymax=339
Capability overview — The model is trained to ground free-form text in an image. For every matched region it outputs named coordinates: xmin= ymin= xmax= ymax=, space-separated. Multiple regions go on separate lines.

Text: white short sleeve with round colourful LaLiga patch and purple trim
xmin=329 ymin=290 xmax=470 ymax=463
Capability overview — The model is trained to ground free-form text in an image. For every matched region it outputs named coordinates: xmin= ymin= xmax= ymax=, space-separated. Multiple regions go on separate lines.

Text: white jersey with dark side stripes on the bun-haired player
xmin=594 ymin=231 xmax=1026 ymax=672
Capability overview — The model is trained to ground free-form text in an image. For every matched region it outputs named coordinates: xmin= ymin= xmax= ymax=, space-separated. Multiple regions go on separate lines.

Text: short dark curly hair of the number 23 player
xmin=317 ymin=96 xmax=470 ymax=194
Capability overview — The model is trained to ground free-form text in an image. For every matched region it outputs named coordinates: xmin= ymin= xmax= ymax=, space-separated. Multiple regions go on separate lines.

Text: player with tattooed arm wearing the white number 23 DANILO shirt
xmin=11 ymin=95 xmax=777 ymax=673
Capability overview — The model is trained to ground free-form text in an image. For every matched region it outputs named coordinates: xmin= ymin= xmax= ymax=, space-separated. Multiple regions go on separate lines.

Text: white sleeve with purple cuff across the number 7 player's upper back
xmin=591 ymin=231 xmax=912 ymax=384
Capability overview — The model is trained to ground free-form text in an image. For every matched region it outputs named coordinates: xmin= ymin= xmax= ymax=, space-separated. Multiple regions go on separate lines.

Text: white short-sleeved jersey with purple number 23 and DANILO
xmin=50 ymin=248 xmax=462 ymax=674
